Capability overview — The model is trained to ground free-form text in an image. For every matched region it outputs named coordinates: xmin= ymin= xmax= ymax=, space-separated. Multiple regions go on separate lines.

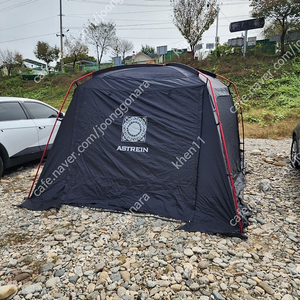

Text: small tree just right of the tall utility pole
xmin=65 ymin=35 xmax=89 ymax=71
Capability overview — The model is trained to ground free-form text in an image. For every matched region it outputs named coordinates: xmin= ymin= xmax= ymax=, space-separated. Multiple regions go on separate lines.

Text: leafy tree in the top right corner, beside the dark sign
xmin=250 ymin=0 xmax=300 ymax=55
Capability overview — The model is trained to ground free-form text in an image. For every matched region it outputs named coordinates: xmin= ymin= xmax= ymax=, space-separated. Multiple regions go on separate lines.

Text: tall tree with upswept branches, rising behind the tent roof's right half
xmin=170 ymin=0 xmax=219 ymax=54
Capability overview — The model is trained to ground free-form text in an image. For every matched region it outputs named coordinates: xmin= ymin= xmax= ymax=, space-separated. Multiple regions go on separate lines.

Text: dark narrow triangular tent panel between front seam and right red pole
xmin=183 ymin=78 xmax=240 ymax=235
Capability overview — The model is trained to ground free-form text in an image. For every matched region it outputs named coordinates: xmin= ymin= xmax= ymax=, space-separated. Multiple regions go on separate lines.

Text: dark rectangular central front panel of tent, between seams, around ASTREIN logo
xmin=63 ymin=81 xmax=204 ymax=220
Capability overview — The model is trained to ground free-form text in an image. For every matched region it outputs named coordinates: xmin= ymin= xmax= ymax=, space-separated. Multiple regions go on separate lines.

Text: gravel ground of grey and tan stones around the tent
xmin=0 ymin=139 xmax=300 ymax=300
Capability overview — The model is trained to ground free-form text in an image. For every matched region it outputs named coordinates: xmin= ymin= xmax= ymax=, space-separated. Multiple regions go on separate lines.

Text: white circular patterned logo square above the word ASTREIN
xmin=122 ymin=117 xmax=147 ymax=142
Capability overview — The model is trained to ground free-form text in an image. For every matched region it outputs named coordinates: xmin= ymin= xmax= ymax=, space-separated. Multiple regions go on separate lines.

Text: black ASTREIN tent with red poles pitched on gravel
xmin=21 ymin=64 xmax=248 ymax=236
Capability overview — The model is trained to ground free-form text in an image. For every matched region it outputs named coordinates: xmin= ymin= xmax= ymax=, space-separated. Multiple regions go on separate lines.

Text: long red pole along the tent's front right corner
xmin=199 ymin=72 xmax=243 ymax=233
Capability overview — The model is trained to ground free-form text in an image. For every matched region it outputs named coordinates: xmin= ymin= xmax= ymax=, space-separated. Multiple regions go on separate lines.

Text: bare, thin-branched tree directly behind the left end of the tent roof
xmin=85 ymin=22 xmax=116 ymax=68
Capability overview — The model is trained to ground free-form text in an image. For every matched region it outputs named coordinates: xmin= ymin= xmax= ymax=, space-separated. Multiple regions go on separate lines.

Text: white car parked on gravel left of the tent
xmin=0 ymin=97 xmax=63 ymax=176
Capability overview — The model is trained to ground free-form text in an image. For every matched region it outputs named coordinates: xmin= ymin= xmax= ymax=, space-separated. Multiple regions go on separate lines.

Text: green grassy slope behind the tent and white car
xmin=0 ymin=53 xmax=300 ymax=139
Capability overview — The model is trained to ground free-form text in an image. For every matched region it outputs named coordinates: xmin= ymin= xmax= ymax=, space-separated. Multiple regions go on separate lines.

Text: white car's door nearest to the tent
xmin=23 ymin=101 xmax=60 ymax=151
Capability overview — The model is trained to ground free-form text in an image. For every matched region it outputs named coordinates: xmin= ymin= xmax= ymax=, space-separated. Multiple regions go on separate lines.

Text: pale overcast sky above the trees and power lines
xmin=0 ymin=0 xmax=261 ymax=62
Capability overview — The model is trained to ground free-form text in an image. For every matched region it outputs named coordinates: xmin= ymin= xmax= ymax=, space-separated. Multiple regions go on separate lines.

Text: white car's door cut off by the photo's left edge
xmin=0 ymin=101 xmax=40 ymax=159
